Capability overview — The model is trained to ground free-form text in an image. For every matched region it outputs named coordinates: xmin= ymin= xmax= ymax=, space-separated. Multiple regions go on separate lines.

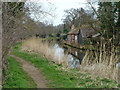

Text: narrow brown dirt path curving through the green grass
xmin=11 ymin=55 xmax=47 ymax=88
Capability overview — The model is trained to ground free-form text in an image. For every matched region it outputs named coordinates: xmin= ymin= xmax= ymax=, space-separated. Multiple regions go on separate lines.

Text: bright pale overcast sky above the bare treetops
xmin=26 ymin=0 xmax=97 ymax=25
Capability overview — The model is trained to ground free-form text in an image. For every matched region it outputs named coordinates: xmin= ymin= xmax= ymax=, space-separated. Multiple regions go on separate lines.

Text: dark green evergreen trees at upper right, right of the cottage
xmin=98 ymin=2 xmax=120 ymax=43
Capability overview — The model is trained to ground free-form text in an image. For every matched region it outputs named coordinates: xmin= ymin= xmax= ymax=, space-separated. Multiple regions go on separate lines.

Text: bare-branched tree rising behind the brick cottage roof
xmin=63 ymin=8 xmax=97 ymax=30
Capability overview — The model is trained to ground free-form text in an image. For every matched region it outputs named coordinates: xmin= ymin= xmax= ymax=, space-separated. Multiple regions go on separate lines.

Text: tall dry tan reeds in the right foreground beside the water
xmin=80 ymin=40 xmax=119 ymax=81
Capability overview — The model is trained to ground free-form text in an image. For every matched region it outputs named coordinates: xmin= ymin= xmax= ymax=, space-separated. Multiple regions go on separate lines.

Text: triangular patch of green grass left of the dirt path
xmin=3 ymin=56 xmax=37 ymax=88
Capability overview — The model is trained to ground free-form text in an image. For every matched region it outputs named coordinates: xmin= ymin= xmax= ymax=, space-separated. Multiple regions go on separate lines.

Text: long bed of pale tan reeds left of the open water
xmin=22 ymin=37 xmax=69 ymax=67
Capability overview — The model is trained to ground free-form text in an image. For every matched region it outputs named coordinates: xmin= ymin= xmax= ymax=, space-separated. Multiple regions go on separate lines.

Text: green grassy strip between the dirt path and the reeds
xmin=12 ymin=43 xmax=117 ymax=88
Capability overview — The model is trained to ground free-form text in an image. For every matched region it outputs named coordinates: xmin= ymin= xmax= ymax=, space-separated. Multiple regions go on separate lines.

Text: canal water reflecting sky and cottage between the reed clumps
xmin=54 ymin=44 xmax=84 ymax=68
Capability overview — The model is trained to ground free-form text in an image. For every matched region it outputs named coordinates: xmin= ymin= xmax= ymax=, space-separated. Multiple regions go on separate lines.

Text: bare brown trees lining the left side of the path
xmin=2 ymin=2 xmax=56 ymax=80
